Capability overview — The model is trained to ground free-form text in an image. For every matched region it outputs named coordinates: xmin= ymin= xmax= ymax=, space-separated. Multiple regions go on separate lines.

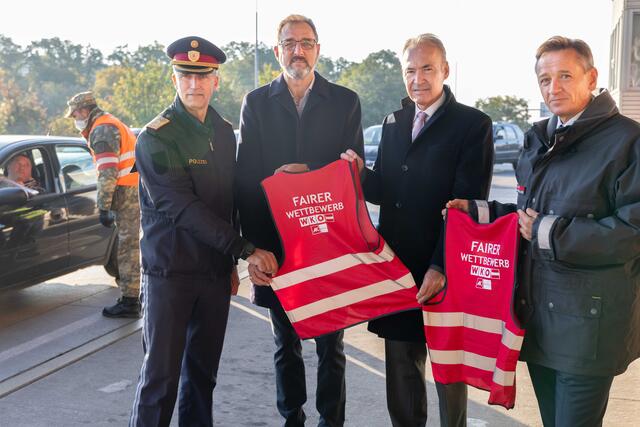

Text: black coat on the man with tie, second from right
xmin=364 ymin=86 xmax=493 ymax=342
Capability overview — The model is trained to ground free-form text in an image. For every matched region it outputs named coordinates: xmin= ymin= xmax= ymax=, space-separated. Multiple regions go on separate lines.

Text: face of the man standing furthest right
xmin=536 ymin=49 xmax=598 ymax=123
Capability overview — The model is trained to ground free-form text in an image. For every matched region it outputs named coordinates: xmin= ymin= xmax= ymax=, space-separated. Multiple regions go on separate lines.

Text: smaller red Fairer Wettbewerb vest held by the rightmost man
xmin=423 ymin=209 xmax=524 ymax=409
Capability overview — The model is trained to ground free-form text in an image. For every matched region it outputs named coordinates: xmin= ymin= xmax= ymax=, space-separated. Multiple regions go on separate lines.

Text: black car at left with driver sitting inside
xmin=0 ymin=135 xmax=117 ymax=289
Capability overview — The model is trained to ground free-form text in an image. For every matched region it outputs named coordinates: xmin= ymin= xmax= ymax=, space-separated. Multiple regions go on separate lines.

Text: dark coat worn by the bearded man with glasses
xmin=236 ymin=73 xmax=364 ymax=307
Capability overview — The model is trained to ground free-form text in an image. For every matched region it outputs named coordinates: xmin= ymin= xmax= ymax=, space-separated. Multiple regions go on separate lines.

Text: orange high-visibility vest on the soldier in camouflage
xmin=88 ymin=113 xmax=138 ymax=187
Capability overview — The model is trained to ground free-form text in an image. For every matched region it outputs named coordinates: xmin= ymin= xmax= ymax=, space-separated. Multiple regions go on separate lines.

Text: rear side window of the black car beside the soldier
xmin=56 ymin=145 xmax=96 ymax=191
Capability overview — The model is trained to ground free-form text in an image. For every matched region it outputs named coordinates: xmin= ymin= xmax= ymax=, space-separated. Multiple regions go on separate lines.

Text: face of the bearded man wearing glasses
xmin=273 ymin=22 xmax=320 ymax=80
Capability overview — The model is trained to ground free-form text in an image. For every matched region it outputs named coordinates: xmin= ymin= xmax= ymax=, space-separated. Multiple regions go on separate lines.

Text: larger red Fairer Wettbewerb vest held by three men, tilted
xmin=262 ymin=160 xmax=420 ymax=339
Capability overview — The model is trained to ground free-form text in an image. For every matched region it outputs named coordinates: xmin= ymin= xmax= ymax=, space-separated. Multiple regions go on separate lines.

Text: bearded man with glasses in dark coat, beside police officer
xmin=236 ymin=15 xmax=364 ymax=426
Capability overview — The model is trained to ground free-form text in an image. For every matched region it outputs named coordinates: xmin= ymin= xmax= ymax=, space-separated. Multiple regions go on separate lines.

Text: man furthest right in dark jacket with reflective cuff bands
xmin=447 ymin=36 xmax=640 ymax=426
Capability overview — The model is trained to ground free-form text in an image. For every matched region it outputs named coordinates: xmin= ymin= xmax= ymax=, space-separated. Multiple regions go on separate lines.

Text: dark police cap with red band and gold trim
xmin=167 ymin=36 xmax=227 ymax=73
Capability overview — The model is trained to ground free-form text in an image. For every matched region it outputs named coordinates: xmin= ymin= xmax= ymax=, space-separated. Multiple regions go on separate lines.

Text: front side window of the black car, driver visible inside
xmin=0 ymin=148 xmax=53 ymax=195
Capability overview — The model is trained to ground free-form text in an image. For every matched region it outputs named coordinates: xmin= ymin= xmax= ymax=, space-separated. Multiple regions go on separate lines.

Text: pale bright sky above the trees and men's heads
xmin=0 ymin=0 xmax=613 ymax=115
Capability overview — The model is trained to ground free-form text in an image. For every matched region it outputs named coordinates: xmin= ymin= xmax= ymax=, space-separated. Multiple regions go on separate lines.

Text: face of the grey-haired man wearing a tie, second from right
xmin=402 ymin=43 xmax=449 ymax=110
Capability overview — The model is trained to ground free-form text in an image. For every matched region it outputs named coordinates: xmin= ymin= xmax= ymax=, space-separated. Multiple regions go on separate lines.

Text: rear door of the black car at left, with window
xmin=55 ymin=142 xmax=115 ymax=266
